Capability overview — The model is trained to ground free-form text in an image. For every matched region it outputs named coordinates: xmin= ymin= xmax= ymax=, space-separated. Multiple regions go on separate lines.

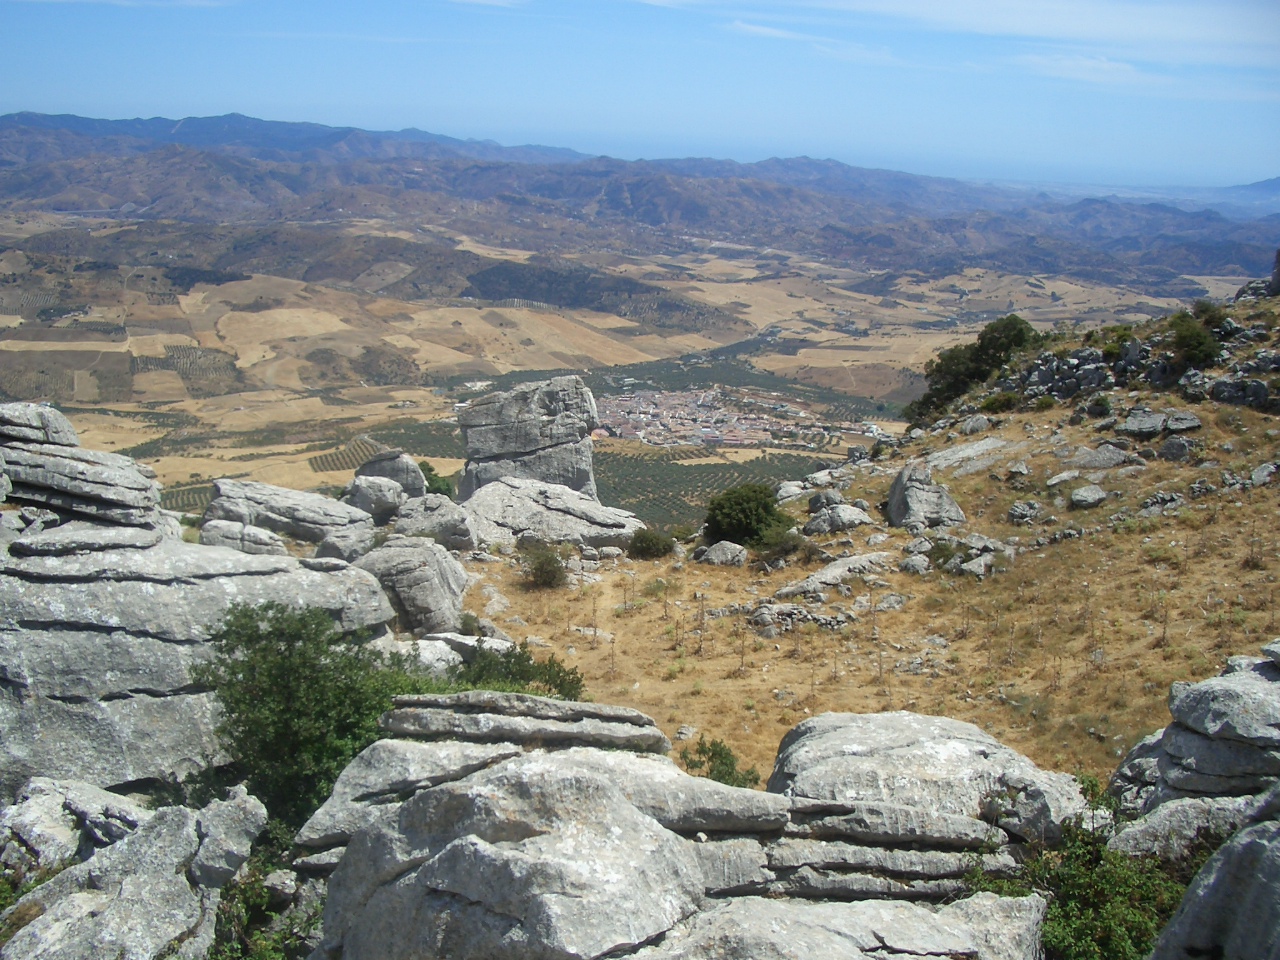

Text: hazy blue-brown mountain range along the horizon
xmin=0 ymin=113 xmax=1280 ymax=296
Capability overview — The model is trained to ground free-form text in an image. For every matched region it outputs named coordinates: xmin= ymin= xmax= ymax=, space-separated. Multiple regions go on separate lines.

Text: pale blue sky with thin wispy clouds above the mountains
xmin=0 ymin=0 xmax=1280 ymax=186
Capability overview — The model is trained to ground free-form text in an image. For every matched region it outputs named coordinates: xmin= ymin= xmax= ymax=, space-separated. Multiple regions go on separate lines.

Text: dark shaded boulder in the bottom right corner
xmin=1149 ymin=787 xmax=1280 ymax=960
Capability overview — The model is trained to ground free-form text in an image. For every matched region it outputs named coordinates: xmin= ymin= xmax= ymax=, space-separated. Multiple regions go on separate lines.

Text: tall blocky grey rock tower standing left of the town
xmin=458 ymin=376 xmax=598 ymax=500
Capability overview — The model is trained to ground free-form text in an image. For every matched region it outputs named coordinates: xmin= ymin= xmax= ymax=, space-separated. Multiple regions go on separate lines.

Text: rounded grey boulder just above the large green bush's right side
xmin=353 ymin=535 xmax=468 ymax=634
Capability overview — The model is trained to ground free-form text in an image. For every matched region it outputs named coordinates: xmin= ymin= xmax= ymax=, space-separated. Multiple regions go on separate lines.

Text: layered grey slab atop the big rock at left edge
xmin=4 ymin=440 xmax=160 ymax=526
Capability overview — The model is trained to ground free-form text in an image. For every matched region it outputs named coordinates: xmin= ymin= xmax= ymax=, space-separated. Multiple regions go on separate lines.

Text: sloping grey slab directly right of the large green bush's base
xmin=293 ymin=740 xmax=522 ymax=847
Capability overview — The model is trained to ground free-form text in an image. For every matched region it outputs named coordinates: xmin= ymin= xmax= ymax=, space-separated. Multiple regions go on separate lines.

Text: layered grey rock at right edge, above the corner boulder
xmin=1111 ymin=643 xmax=1280 ymax=815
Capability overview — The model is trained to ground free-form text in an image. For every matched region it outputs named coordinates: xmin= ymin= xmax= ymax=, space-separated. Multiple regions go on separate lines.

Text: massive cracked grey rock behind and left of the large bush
xmin=0 ymin=522 xmax=393 ymax=797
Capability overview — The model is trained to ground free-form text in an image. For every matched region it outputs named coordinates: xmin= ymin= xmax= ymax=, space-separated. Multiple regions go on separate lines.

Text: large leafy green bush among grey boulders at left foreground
xmin=193 ymin=603 xmax=443 ymax=827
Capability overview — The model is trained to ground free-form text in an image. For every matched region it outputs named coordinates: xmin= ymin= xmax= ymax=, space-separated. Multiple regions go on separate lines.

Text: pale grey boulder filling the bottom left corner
xmin=0 ymin=788 xmax=266 ymax=960
